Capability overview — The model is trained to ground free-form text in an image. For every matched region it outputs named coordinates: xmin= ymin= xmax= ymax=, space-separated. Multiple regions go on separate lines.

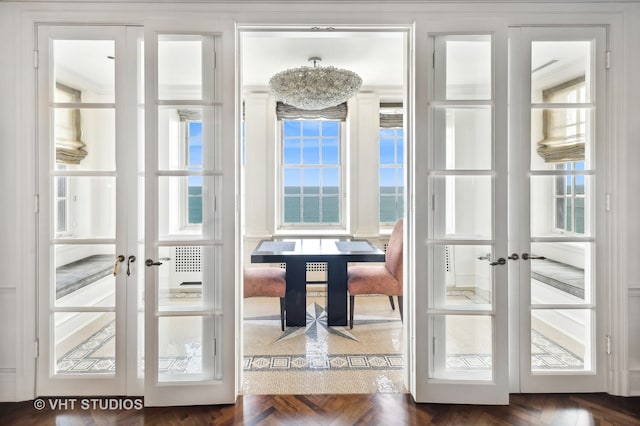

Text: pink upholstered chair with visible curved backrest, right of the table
xmin=347 ymin=219 xmax=403 ymax=328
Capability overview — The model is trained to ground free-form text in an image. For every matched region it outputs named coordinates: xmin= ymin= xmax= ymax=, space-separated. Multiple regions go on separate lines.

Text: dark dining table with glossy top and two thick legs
xmin=251 ymin=238 xmax=385 ymax=327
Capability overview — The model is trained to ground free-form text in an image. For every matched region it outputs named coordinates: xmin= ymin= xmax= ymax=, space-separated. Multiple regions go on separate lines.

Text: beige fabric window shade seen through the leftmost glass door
xmin=55 ymin=83 xmax=88 ymax=164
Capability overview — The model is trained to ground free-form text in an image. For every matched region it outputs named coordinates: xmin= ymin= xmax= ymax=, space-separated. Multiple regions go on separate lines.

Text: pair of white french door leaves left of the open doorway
xmin=37 ymin=20 xmax=237 ymax=405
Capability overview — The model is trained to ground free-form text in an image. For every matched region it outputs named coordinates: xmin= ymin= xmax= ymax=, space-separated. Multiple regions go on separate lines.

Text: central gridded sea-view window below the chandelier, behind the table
xmin=278 ymin=120 xmax=344 ymax=229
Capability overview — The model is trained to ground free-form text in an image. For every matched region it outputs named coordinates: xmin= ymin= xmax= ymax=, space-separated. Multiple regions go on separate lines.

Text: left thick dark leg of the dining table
xmin=285 ymin=259 xmax=307 ymax=327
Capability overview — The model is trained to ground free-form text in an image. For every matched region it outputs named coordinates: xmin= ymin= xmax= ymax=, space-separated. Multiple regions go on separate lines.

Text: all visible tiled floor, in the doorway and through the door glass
xmin=58 ymin=292 xmax=583 ymax=394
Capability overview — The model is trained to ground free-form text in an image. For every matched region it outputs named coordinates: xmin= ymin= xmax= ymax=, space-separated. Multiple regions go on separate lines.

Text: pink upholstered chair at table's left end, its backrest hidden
xmin=244 ymin=266 xmax=287 ymax=331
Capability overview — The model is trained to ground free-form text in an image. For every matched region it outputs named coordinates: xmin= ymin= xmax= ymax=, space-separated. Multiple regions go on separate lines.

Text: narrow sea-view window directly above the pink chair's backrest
xmin=379 ymin=129 xmax=404 ymax=224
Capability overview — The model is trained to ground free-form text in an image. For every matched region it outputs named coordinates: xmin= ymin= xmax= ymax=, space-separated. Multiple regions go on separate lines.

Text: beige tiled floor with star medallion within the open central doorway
xmin=242 ymin=293 xmax=406 ymax=395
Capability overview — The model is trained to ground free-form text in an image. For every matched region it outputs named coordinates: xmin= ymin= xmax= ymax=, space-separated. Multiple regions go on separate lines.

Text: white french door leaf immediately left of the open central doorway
xmin=143 ymin=20 xmax=239 ymax=405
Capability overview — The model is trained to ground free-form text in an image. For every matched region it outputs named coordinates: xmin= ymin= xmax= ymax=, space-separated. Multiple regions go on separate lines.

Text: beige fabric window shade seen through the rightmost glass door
xmin=537 ymin=76 xmax=586 ymax=163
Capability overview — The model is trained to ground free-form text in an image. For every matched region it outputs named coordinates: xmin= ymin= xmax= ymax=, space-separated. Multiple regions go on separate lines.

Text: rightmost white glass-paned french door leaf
xmin=509 ymin=27 xmax=607 ymax=392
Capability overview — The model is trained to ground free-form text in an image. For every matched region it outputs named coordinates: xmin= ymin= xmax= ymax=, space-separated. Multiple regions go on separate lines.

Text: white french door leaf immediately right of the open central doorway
xmin=414 ymin=32 xmax=509 ymax=404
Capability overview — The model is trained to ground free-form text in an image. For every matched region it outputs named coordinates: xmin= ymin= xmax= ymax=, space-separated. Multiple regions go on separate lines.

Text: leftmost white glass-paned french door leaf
xmin=37 ymin=25 xmax=144 ymax=395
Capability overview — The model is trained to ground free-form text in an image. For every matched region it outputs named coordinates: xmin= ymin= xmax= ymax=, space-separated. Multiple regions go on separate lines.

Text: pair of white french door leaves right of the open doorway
xmin=413 ymin=27 xmax=606 ymax=404
